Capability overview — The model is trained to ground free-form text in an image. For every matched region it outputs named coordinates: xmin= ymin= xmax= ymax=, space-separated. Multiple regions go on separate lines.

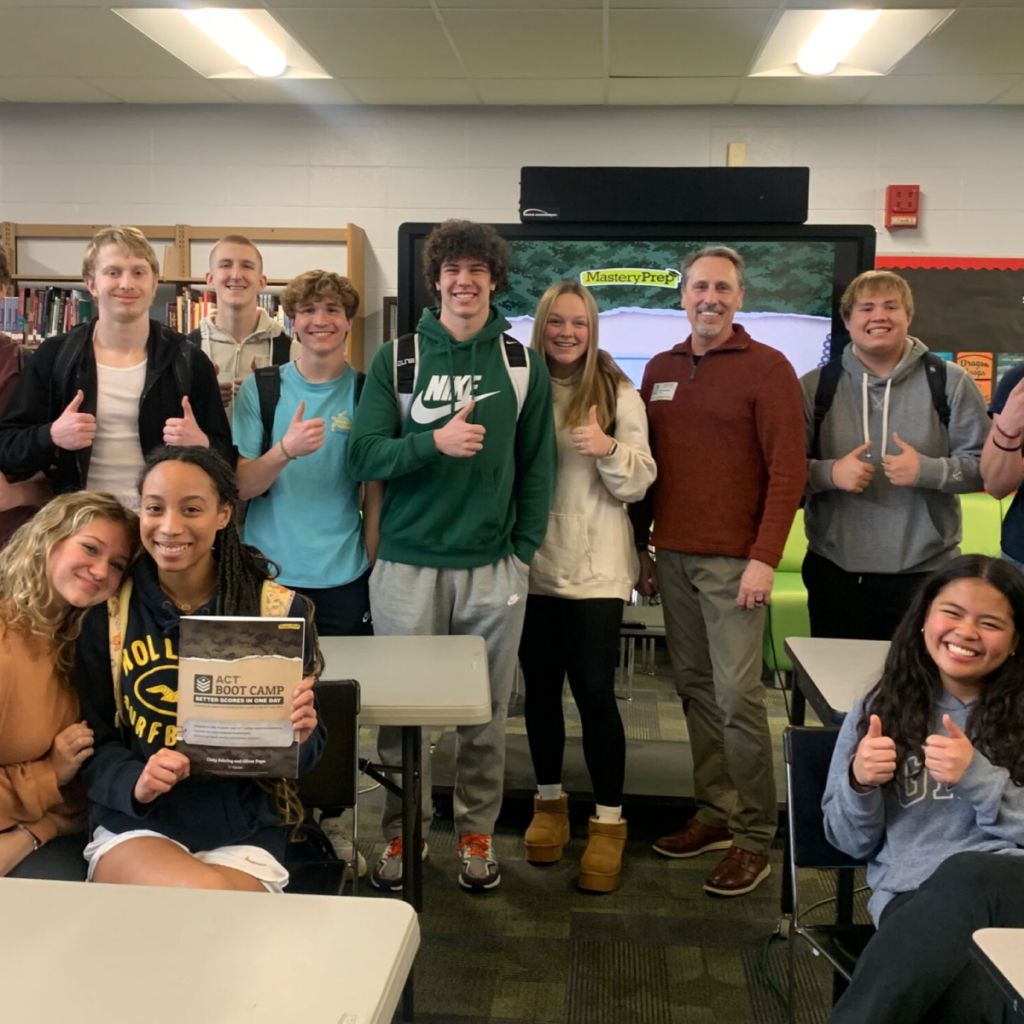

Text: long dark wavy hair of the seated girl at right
xmin=857 ymin=555 xmax=1024 ymax=785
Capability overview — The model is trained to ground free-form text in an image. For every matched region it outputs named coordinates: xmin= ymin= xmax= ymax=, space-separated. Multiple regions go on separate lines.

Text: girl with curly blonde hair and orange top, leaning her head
xmin=0 ymin=490 xmax=138 ymax=876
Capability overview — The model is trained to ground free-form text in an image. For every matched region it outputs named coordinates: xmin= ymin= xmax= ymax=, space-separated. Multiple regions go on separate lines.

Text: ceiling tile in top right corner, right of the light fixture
xmin=893 ymin=7 xmax=1024 ymax=75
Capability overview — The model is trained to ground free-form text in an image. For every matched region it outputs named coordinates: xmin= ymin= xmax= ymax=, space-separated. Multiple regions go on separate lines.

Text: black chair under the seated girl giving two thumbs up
xmin=782 ymin=725 xmax=874 ymax=1024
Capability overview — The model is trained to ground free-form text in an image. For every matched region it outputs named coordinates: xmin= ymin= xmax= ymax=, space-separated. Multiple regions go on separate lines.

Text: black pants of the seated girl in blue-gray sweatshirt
xmin=828 ymin=853 xmax=1024 ymax=1024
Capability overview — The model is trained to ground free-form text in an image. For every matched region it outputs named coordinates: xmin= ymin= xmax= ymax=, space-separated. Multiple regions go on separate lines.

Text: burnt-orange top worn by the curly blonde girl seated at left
xmin=0 ymin=629 xmax=85 ymax=843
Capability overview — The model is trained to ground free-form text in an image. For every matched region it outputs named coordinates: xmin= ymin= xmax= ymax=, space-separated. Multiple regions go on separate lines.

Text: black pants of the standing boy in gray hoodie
xmin=801 ymin=551 xmax=931 ymax=640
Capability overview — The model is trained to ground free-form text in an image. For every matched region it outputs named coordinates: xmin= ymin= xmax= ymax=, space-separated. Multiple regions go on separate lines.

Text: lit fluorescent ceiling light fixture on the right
xmin=748 ymin=8 xmax=953 ymax=78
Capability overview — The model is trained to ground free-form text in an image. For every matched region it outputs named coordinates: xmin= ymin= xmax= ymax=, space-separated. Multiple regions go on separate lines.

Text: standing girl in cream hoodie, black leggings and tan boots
xmin=519 ymin=281 xmax=656 ymax=892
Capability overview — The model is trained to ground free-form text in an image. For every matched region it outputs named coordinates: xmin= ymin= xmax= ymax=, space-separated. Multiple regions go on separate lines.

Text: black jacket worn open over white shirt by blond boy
xmin=0 ymin=321 xmax=236 ymax=493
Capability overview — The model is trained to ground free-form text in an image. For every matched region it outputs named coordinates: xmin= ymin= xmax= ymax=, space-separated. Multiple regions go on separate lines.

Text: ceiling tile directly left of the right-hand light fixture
xmin=610 ymin=10 xmax=772 ymax=78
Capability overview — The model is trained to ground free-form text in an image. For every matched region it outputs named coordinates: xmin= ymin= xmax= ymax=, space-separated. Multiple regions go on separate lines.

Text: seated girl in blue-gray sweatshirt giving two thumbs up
xmin=823 ymin=555 xmax=1024 ymax=1024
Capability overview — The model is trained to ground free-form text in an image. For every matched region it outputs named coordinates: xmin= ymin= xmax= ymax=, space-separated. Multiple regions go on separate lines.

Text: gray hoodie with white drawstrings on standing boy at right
xmin=800 ymin=338 xmax=989 ymax=572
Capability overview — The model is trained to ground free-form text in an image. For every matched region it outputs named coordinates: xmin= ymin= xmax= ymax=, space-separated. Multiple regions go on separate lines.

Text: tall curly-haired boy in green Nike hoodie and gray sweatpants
xmin=348 ymin=220 xmax=557 ymax=891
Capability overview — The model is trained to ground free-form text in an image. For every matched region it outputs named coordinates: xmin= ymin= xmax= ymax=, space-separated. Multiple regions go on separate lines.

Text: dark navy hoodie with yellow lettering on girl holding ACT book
xmin=75 ymin=555 xmax=327 ymax=860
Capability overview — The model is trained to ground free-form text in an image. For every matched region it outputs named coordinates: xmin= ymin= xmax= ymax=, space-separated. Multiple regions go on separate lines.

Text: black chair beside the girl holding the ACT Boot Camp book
xmin=287 ymin=679 xmax=359 ymax=896
